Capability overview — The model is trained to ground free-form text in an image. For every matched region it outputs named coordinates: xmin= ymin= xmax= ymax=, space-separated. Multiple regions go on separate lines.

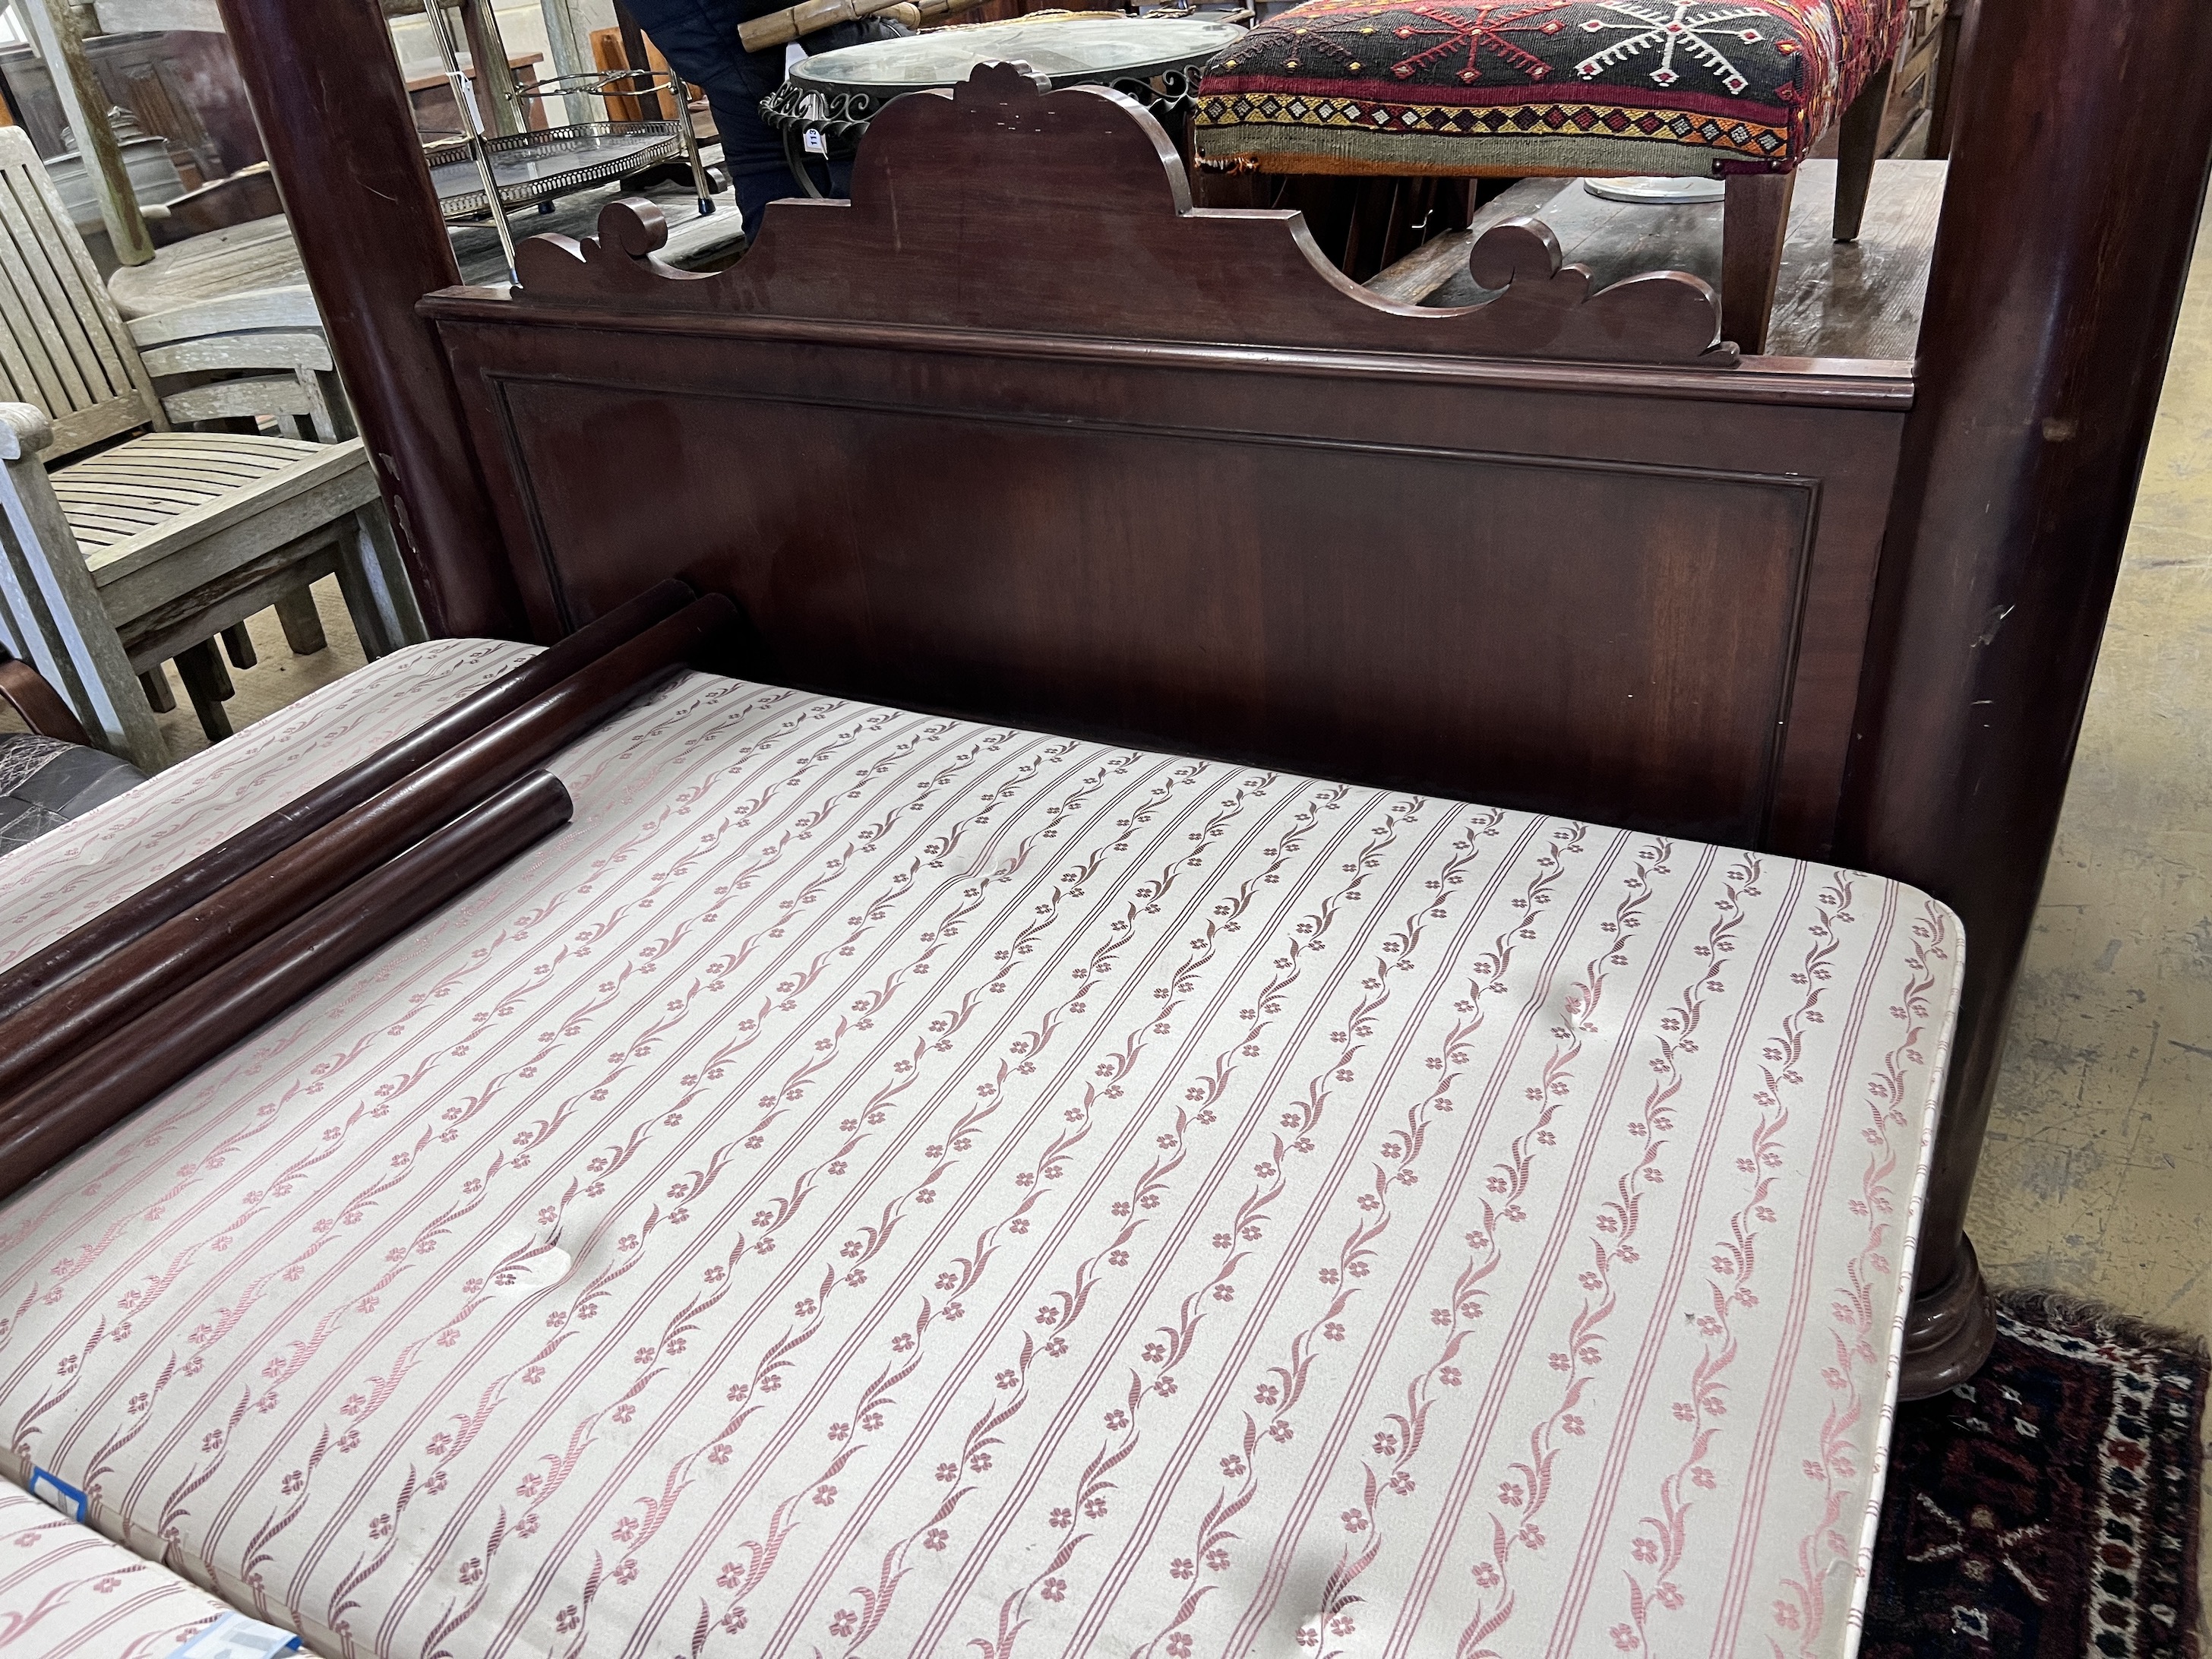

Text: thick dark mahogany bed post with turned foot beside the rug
xmin=1838 ymin=0 xmax=2212 ymax=1398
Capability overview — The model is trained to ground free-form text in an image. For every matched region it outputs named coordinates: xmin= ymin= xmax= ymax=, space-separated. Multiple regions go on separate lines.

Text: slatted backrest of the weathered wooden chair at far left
xmin=0 ymin=126 xmax=168 ymax=463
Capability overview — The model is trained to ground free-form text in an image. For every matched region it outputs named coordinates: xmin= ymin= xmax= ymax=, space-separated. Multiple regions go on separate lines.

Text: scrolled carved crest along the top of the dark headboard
xmin=517 ymin=64 xmax=1736 ymax=369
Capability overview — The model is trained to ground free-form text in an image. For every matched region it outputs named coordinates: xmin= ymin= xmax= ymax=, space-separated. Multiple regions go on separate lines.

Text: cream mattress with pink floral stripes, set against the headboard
xmin=0 ymin=641 xmax=1960 ymax=1659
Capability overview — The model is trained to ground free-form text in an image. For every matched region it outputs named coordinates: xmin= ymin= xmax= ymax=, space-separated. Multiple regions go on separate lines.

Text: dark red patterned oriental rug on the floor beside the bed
xmin=1860 ymin=1292 xmax=2207 ymax=1659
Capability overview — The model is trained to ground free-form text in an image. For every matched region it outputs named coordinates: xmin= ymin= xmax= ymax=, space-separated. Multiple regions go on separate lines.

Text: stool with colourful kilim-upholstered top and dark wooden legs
xmin=1196 ymin=0 xmax=1909 ymax=352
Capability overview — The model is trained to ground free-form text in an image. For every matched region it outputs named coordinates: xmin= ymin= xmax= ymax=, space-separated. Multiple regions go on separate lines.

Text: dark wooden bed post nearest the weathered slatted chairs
xmin=219 ymin=0 xmax=522 ymax=637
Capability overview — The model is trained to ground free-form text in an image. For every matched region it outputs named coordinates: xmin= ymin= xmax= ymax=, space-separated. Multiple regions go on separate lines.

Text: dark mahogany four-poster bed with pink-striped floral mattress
xmin=0 ymin=0 xmax=2212 ymax=1659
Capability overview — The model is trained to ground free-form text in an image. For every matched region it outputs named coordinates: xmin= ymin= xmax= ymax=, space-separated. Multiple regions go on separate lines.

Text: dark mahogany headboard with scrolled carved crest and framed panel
xmin=422 ymin=66 xmax=1911 ymax=854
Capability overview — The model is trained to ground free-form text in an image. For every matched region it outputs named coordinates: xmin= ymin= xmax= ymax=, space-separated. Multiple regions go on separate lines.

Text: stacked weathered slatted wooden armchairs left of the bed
xmin=0 ymin=128 xmax=425 ymax=772
